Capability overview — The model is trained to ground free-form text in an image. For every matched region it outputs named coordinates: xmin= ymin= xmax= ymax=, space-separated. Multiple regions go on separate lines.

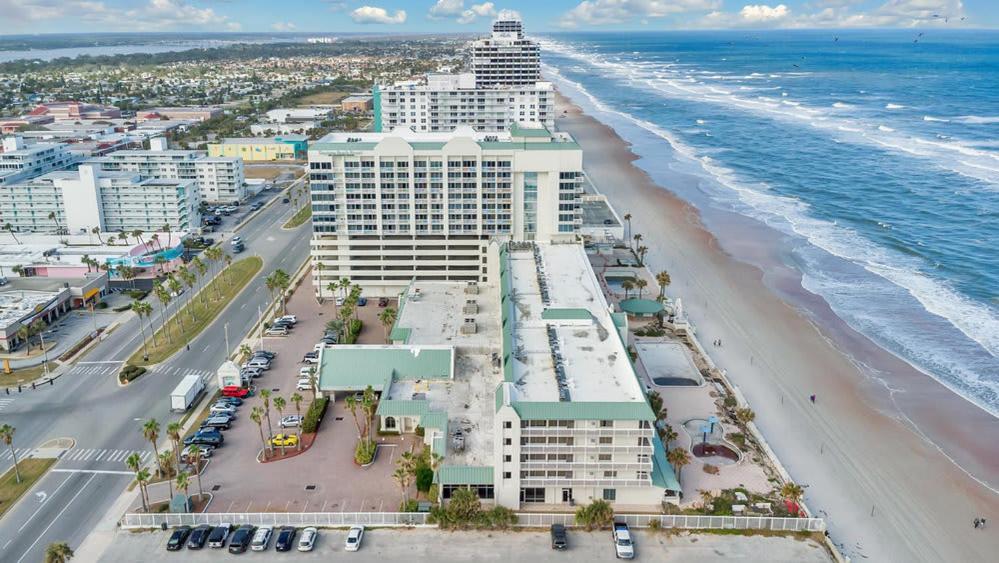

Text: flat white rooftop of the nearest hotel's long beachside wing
xmin=508 ymin=244 xmax=645 ymax=402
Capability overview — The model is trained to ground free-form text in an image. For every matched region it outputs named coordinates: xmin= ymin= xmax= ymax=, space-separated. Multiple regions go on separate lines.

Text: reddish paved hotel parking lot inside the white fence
xmin=161 ymin=275 xmax=410 ymax=512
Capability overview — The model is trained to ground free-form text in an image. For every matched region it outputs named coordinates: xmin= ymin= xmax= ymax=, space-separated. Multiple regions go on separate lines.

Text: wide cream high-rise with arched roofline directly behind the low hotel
xmin=309 ymin=125 xmax=583 ymax=295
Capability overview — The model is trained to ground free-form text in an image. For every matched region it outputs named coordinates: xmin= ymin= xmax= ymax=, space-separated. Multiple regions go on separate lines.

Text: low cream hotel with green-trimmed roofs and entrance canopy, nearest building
xmin=319 ymin=241 xmax=680 ymax=512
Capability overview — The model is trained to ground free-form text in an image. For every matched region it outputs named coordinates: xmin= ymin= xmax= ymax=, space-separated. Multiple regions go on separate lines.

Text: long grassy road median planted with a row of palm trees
xmin=128 ymin=256 xmax=264 ymax=366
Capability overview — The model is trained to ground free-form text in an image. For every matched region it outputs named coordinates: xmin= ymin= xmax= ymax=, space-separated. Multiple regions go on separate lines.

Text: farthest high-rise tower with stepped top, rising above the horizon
xmin=472 ymin=20 xmax=541 ymax=88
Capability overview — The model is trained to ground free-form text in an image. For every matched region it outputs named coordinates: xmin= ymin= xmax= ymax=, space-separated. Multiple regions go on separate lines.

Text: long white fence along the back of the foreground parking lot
xmin=121 ymin=512 xmax=826 ymax=532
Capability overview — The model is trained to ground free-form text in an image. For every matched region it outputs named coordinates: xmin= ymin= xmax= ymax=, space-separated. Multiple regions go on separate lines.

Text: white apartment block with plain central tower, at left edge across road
xmin=0 ymin=163 xmax=200 ymax=234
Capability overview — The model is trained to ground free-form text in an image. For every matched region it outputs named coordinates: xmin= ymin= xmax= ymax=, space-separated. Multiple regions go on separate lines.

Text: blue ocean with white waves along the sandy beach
xmin=540 ymin=30 xmax=999 ymax=415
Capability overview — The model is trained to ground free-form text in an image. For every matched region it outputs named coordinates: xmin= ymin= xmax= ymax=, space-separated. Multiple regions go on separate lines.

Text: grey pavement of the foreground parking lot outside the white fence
xmin=100 ymin=528 xmax=832 ymax=563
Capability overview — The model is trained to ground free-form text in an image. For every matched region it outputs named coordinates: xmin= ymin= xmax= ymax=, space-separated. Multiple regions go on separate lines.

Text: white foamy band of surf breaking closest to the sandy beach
xmin=559 ymin=62 xmax=999 ymax=412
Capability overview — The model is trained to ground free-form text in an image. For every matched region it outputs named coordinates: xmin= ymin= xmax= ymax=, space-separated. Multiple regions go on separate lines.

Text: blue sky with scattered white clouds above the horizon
xmin=0 ymin=0 xmax=999 ymax=34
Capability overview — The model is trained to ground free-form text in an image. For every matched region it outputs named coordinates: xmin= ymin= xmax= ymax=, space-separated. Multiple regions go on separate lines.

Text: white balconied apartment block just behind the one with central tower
xmin=87 ymin=138 xmax=246 ymax=203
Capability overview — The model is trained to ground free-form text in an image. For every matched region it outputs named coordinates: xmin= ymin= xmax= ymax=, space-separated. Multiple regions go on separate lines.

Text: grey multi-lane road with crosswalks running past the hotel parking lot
xmin=0 ymin=182 xmax=311 ymax=563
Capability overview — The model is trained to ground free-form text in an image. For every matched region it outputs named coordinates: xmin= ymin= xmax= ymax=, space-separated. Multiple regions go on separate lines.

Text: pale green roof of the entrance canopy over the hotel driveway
xmin=319 ymin=346 xmax=452 ymax=391
